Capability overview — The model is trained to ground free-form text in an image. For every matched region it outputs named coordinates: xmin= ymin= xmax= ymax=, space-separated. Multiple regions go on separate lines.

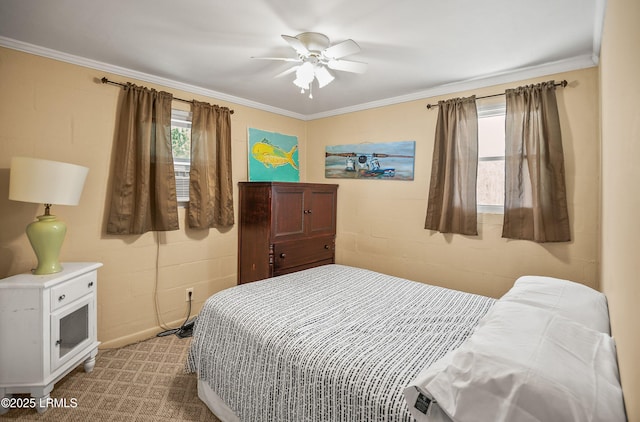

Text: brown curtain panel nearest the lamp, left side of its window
xmin=107 ymin=84 xmax=178 ymax=234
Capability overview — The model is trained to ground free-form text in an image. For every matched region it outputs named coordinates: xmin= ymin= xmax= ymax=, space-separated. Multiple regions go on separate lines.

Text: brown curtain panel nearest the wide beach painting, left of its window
xmin=424 ymin=96 xmax=478 ymax=235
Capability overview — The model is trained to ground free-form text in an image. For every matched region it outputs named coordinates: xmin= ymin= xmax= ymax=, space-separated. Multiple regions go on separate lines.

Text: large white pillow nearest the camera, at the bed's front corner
xmin=405 ymin=301 xmax=626 ymax=422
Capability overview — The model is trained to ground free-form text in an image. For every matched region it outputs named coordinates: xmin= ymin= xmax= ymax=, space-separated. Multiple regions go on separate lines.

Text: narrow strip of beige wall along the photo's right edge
xmin=601 ymin=0 xmax=640 ymax=421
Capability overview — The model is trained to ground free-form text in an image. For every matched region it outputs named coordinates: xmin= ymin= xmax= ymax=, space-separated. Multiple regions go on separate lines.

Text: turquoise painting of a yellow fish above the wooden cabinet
xmin=248 ymin=128 xmax=300 ymax=182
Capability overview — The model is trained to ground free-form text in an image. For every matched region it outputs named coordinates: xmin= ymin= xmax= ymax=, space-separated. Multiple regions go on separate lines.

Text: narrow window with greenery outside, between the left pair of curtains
xmin=171 ymin=110 xmax=191 ymax=202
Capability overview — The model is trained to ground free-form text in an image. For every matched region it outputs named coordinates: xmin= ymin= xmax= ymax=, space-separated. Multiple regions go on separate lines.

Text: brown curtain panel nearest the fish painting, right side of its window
xmin=188 ymin=101 xmax=234 ymax=229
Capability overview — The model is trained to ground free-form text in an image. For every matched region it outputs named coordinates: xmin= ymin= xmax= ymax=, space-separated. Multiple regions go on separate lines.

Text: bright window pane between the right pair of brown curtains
xmin=476 ymin=103 xmax=505 ymax=214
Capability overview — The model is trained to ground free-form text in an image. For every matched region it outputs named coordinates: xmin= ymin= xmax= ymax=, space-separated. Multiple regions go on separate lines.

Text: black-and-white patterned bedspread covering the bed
xmin=187 ymin=265 xmax=495 ymax=422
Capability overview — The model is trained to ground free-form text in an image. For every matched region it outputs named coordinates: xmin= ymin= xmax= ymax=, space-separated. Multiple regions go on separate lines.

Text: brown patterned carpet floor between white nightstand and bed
xmin=0 ymin=335 xmax=219 ymax=422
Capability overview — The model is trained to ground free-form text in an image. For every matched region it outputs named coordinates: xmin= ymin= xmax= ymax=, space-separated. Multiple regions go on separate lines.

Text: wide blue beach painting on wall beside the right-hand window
xmin=324 ymin=141 xmax=416 ymax=180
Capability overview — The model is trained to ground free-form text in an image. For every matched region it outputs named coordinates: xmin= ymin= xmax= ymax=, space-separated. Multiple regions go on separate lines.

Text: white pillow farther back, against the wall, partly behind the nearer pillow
xmin=500 ymin=276 xmax=611 ymax=334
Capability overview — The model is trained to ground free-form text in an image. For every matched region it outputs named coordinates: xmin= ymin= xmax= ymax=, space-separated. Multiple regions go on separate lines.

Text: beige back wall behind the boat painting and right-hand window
xmin=307 ymin=68 xmax=600 ymax=296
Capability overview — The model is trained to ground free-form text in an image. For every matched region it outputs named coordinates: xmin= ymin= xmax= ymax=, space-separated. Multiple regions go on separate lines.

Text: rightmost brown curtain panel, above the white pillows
xmin=502 ymin=81 xmax=571 ymax=242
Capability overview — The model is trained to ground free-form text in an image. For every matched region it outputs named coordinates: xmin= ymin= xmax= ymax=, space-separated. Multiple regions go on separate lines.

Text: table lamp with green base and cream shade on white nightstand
xmin=9 ymin=157 xmax=89 ymax=274
